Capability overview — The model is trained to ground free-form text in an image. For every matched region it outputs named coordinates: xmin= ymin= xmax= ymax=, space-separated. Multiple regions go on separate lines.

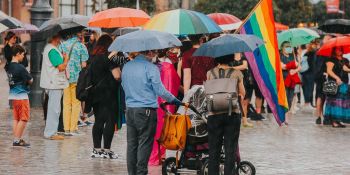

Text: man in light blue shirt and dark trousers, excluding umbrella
xmin=122 ymin=50 xmax=181 ymax=175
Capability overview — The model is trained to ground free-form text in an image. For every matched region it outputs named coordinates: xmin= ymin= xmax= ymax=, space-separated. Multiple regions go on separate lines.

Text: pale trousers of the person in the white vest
xmin=44 ymin=90 xmax=63 ymax=138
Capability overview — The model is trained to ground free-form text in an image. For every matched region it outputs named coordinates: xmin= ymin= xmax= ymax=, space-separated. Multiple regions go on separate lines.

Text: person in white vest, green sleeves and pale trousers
xmin=40 ymin=35 xmax=69 ymax=140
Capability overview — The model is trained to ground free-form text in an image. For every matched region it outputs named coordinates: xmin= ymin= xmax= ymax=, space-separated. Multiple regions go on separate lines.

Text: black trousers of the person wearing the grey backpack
xmin=208 ymin=114 xmax=241 ymax=175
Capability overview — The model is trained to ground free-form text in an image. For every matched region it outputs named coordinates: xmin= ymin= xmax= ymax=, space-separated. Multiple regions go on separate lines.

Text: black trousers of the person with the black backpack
xmin=92 ymin=102 xmax=117 ymax=149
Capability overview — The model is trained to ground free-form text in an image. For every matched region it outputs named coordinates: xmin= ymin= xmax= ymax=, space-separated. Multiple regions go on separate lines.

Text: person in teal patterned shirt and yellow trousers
xmin=60 ymin=32 xmax=89 ymax=136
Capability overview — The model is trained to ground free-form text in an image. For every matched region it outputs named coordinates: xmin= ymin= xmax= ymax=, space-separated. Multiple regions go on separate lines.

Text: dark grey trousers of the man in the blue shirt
xmin=126 ymin=108 xmax=157 ymax=175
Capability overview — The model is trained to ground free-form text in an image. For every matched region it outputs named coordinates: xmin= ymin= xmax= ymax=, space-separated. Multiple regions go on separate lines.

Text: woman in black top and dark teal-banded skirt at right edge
xmin=324 ymin=47 xmax=350 ymax=128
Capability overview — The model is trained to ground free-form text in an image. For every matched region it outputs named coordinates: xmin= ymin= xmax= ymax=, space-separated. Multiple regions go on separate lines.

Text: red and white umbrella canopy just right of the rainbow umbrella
xmin=207 ymin=13 xmax=242 ymax=30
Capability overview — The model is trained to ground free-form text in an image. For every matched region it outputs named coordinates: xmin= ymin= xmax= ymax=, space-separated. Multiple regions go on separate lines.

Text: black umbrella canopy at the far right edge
xmin=319 ymin=19 xmax=350 ymax=34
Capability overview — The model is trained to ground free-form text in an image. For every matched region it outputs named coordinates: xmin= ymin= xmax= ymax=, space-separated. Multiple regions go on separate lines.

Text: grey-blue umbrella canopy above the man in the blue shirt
xmin=108 ymin=30 xmax=182 ymax=52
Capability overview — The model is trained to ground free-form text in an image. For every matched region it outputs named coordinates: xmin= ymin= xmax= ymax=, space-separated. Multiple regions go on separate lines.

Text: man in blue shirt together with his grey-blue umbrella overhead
xmin=108 ymin=30 xmax=181 ymax=175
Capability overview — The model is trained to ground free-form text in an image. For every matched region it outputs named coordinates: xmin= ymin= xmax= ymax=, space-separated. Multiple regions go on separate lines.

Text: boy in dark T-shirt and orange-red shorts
xmin=7 ymin=45 xmax=33 ymax=147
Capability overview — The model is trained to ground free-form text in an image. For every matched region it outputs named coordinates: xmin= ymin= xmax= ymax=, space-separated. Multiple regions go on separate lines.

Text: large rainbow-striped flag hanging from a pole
xmin=239 ymin=0 xmax=288 ymax=125
